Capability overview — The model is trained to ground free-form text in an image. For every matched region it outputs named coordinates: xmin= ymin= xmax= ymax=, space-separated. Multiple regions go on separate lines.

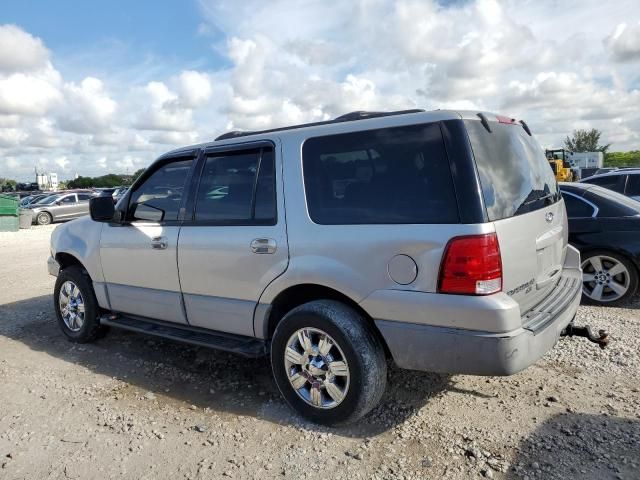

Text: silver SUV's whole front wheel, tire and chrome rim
xmin=53 ymin=265 xmax=104 ymax=343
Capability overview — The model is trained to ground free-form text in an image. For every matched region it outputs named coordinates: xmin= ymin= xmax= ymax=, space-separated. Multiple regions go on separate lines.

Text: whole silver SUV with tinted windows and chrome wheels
xmin=49 ymin=110 xmax=582 ymax=424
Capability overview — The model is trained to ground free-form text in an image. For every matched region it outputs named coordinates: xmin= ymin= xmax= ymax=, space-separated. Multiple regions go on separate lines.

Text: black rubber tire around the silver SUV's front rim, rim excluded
xmin=53 ymin=266 xmax=100 ymax=343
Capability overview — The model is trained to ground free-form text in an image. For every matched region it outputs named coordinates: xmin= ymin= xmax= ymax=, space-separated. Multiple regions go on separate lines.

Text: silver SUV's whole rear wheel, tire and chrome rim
xmin=271 ymin=300 xmax=387 ymax=425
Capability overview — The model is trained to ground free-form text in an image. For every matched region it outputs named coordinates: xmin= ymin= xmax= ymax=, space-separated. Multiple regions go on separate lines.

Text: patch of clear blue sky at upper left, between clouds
xmin=0 ymin=0 xmax=227 ymax=79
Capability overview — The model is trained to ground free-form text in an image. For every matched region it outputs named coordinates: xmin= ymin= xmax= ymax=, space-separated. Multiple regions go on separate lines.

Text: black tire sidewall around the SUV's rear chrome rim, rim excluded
xmin=271 ymin=302 xmax=386 ymax=425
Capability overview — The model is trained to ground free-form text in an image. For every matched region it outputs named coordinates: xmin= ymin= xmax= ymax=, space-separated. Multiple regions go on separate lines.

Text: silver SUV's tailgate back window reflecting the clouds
xmin=464 ymin=120 xmax=560 ymax=221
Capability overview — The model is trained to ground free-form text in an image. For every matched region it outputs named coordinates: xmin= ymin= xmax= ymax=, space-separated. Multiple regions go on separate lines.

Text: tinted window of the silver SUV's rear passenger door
xmin=195 ymin=149 xmax=276 ymax=224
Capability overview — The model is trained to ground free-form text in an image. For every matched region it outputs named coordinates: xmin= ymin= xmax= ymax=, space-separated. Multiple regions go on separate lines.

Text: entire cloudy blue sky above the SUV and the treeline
xmin=0 ymin=0 xmax=640 ymax=180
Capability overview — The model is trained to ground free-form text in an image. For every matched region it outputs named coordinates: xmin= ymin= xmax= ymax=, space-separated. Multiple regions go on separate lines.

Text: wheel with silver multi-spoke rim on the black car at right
xmin=582 ymin=250 xmax=638 ymax=306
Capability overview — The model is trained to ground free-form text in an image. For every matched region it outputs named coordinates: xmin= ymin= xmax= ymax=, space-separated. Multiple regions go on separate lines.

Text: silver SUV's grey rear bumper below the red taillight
xmin=368 ymin=246 xmax=582 ymax=375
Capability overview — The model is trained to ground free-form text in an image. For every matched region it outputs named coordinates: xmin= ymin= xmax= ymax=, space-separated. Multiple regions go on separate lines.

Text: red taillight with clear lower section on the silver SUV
xmin=438 ymin=233 xmax=502 ymax=295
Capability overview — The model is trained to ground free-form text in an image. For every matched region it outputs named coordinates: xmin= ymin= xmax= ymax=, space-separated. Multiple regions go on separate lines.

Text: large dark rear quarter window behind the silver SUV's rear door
xmin=302 ymin=123 xmax=459 ymax=225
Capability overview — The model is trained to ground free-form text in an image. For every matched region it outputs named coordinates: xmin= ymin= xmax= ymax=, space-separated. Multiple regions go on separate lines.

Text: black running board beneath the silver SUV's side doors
xmin=100 ymin=314 xmax=268 ymax=358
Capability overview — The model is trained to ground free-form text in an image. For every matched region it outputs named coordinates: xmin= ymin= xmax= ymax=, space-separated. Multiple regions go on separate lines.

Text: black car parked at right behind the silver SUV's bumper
xmin=560 ymin=183 xmax=640 ymax=305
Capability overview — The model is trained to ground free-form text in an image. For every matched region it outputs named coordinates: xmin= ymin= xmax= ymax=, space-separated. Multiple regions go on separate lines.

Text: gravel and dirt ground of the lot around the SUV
xmin=0 ymin=227 xmax=640 ymax=479
